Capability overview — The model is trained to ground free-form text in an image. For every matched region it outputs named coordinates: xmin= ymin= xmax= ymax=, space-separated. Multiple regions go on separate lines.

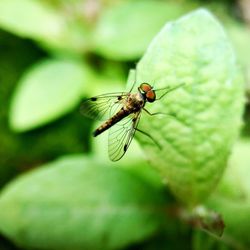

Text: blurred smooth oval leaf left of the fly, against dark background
xmin=9 ymin=60 xmax=89 ymax=132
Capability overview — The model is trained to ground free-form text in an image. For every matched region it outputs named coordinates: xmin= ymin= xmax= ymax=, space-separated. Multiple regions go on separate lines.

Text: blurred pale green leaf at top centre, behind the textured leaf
xmin=94 ymin=0 xmax=190 ymax=60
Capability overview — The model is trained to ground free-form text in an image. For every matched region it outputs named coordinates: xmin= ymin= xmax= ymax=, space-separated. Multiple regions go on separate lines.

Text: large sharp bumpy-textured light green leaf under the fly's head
xmin=130 ymin=9 xmax=244 ymax=205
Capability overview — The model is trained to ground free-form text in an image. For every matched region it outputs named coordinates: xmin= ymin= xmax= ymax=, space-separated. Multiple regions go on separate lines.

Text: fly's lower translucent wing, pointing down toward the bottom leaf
xmin=108 ymin=111 xmax=141 ymax=161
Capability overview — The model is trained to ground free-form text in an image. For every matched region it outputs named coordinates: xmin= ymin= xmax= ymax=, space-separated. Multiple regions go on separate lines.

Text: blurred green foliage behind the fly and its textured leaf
xmin=0 ymin=0 xmax=250 ymax=250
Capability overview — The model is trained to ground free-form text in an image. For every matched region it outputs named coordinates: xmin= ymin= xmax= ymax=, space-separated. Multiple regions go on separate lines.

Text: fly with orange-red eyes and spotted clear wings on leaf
xmin=80 ymin=77 xmax=183 ymax=161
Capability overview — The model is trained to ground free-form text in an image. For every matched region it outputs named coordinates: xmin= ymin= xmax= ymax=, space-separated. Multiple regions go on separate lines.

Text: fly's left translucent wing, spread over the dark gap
xmin=80 ymin=92 xmax=129 ymax=120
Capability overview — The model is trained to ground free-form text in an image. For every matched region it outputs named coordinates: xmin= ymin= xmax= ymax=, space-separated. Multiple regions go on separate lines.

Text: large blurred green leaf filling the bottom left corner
xmin=0 ymin=156 xmax=165 ymax=249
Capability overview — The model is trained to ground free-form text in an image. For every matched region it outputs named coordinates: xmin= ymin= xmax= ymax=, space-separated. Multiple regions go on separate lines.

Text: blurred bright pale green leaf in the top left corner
xmin=0 ymin=0 xmax=89 ymax=54
